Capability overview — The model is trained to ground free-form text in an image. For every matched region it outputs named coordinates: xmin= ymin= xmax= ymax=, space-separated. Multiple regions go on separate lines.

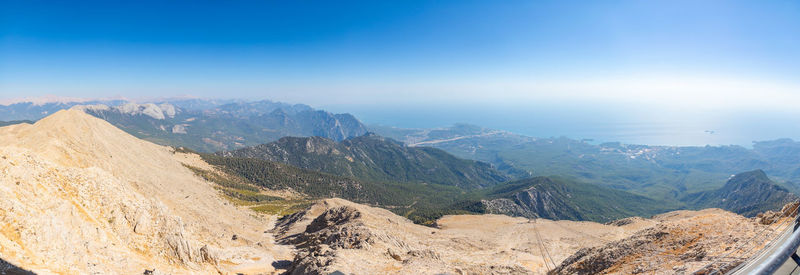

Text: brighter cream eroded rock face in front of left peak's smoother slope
xmin=0 ymin=148 xmax=217 ymax=274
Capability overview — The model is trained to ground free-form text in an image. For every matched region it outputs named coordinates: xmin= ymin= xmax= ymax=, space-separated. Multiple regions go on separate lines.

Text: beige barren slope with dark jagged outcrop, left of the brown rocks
xmin=275 ymin=199 xmax=650 ymax=274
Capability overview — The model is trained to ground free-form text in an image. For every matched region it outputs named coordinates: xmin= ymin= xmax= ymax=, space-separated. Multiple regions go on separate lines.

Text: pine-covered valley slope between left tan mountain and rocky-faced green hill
xmin=201 ymin=154 xmax=478 ymax=224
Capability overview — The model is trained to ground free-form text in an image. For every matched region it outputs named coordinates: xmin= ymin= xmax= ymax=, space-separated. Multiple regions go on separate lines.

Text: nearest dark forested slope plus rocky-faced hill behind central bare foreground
xmin=195 ymin=150 xmax=679 ymax=224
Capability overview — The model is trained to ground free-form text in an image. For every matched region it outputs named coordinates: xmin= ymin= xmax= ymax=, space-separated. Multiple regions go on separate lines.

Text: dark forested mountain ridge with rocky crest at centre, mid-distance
xmin=217 ymin=134 xmax=508 ymax=188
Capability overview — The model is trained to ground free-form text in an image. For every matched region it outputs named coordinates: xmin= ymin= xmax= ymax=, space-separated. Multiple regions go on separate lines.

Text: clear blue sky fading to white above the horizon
xmin=0 ymin=0 xmax=800 ymax=110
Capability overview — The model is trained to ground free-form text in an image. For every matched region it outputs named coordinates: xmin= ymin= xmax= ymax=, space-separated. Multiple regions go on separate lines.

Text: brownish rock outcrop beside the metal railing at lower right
xmin=551 ymin=209 xmax=790 ymax=274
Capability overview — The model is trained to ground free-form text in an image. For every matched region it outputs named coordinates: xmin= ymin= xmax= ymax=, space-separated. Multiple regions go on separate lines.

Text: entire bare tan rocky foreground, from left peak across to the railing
xmin=0 ymin=110 xmax=788 ymax=274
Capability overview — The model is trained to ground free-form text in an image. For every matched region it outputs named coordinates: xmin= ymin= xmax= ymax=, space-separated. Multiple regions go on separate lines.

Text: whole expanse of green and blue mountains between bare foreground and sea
xmin=0 ymin=99 xmax=800 ymax=221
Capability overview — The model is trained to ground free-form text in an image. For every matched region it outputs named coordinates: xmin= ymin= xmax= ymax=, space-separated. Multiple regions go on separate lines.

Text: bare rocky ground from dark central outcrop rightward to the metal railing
xmin=274 ymin=199 xmax=786 ymax=274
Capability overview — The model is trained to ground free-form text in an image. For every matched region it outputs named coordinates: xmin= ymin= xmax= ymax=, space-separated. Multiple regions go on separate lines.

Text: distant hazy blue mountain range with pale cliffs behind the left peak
xmin=0 ymin=99 xmax=367 ymax=152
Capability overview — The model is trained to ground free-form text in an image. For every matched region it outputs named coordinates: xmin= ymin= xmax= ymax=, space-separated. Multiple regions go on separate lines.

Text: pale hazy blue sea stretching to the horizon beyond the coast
xmin=323 ymin=104 xmax=800 ymax=148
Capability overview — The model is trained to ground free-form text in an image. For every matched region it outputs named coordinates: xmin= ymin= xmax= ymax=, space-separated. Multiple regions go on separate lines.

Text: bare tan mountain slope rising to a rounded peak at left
xmin=0 ymin=110 xmax=289 ymax=273
